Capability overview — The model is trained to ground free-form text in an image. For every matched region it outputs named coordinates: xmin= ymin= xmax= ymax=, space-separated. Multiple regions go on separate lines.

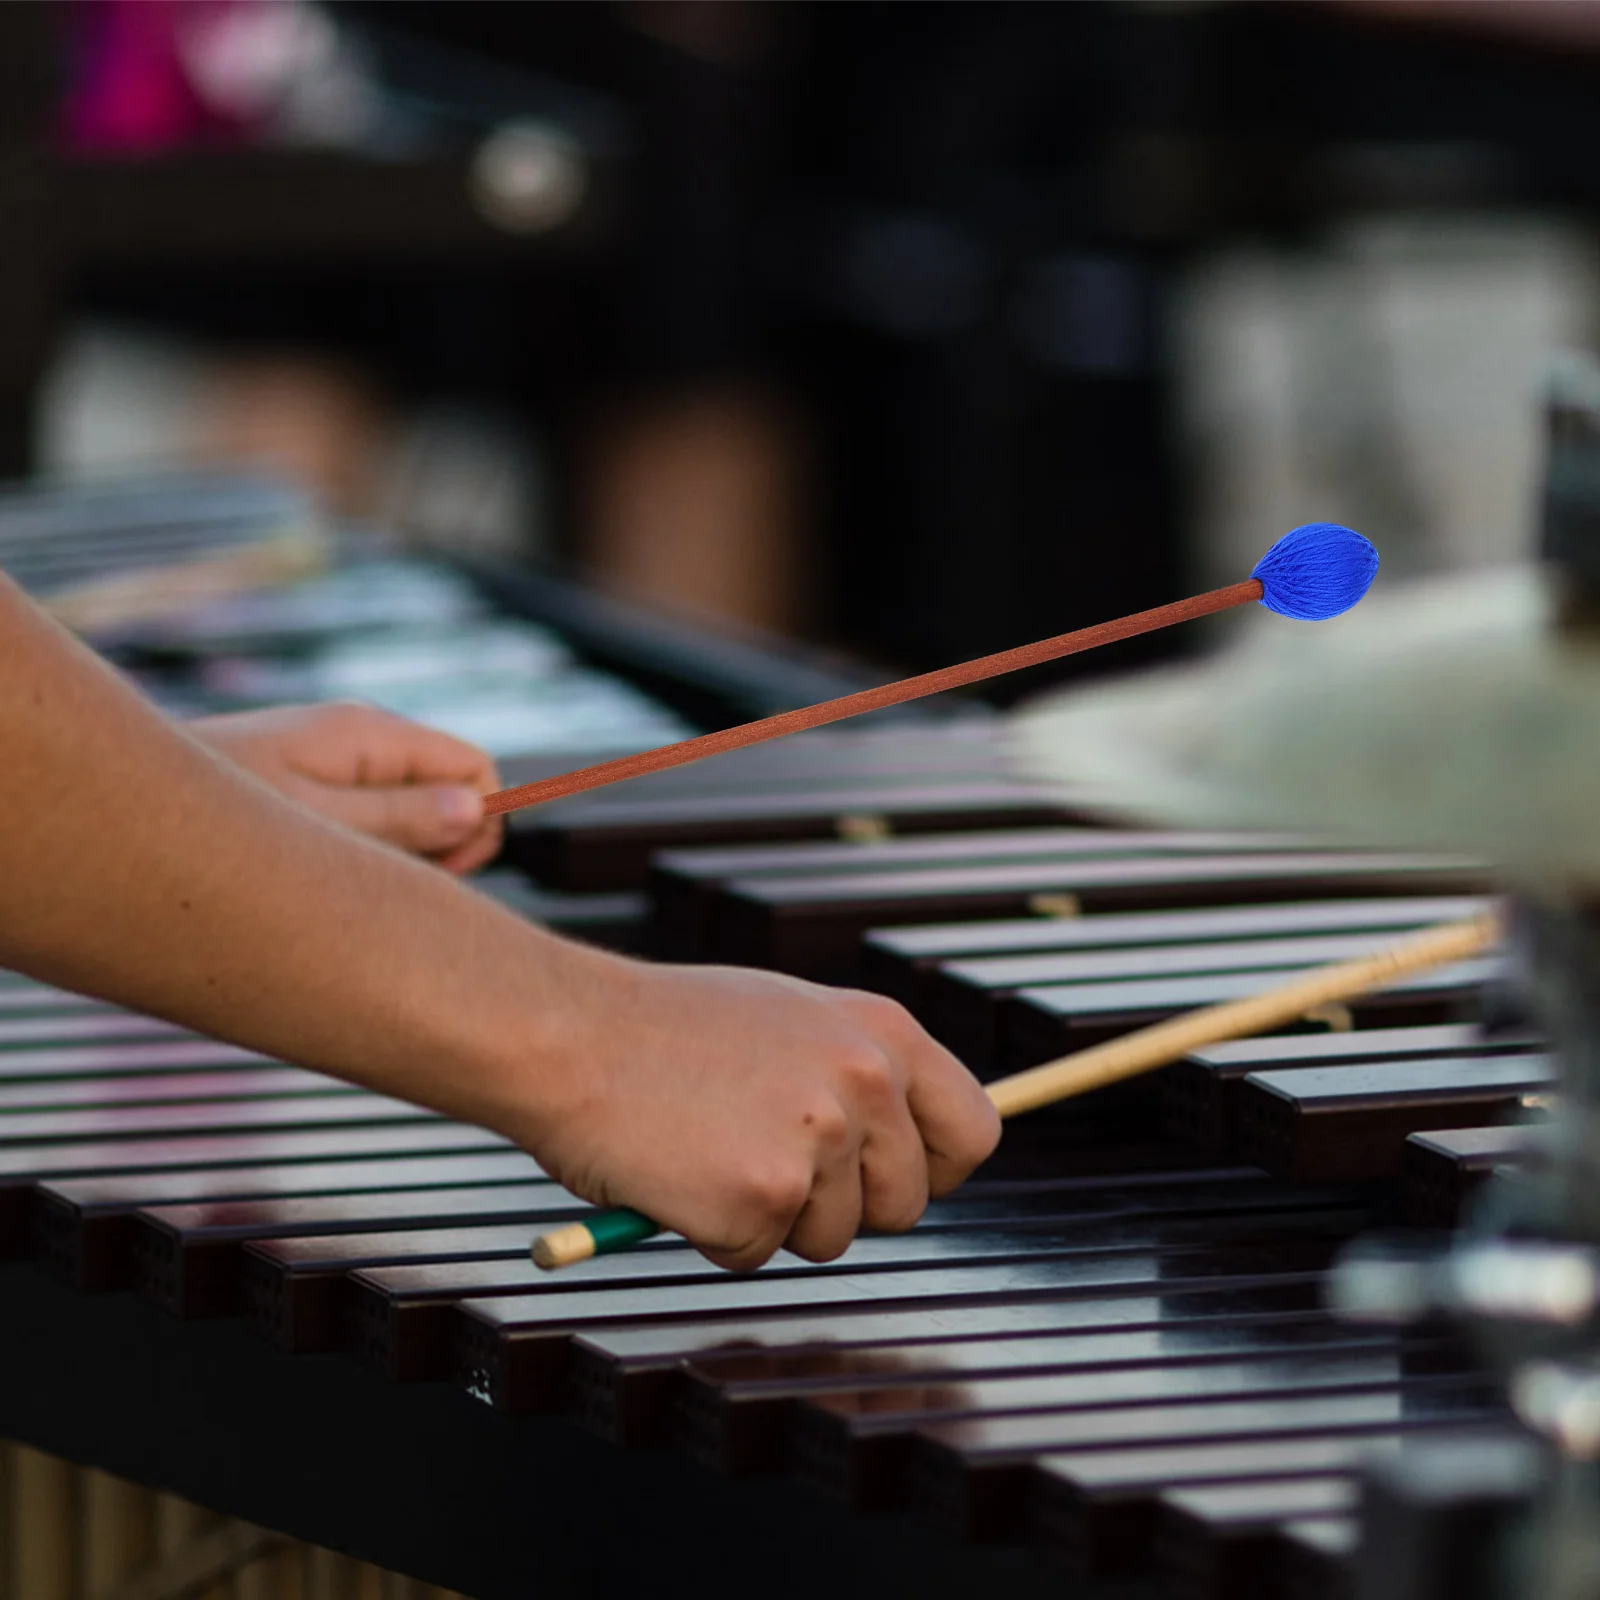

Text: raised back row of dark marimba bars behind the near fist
xmin=510 ymin=742 xmax=1549 ymax=1203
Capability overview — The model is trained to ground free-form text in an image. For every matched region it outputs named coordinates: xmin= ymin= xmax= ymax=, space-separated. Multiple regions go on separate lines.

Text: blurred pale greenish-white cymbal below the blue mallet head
xmin=1010 ymin=568 xmax=1600 ymax=880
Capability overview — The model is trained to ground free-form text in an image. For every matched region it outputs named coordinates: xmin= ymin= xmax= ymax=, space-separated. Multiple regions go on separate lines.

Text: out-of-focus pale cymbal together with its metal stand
xmin=1018 ymin=358 xmax=1600 ymax=1600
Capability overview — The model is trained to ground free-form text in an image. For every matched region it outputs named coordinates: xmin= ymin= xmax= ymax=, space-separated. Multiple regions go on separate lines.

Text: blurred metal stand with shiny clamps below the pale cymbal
xmin=1334 ymin=896 xmax=1600 ymax=1600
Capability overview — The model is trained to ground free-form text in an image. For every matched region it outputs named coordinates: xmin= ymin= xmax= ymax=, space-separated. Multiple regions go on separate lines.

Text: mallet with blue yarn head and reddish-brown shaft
xmin=483 ymin=522 xmax=1378 ymax=816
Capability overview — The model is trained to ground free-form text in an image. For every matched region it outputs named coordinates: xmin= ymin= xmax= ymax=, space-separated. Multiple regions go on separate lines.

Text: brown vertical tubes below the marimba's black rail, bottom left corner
xmin=0 ymin=1443 xmax=462 ymax=1600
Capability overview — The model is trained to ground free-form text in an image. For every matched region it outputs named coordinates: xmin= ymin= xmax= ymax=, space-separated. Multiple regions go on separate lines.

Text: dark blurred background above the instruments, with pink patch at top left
xmin=0 ymin=0 xmax=1600 ymax=698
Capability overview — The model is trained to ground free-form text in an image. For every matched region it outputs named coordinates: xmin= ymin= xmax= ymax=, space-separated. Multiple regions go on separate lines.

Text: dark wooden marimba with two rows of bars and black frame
xmin=0 ymin=726 xmax=1529 ymax=1600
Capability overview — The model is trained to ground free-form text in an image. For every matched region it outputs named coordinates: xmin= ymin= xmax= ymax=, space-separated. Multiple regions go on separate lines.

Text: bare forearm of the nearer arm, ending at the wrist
xmin=0 ymin=584 xmax=598 ymax=1139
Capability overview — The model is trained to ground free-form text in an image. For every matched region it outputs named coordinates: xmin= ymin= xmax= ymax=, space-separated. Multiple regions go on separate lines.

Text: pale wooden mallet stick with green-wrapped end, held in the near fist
xmin=533 ymin=912 xmax=1499 ymax=1270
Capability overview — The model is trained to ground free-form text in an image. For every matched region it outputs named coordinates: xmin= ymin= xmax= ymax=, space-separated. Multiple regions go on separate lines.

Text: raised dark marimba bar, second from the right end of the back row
xmin=1238 ymin=1054 xmax=1555 ymax=1182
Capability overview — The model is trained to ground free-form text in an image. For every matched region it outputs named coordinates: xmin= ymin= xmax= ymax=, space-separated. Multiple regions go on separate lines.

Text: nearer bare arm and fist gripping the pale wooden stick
xmin=0 ymin=579 xmax=998 ymax=1269
